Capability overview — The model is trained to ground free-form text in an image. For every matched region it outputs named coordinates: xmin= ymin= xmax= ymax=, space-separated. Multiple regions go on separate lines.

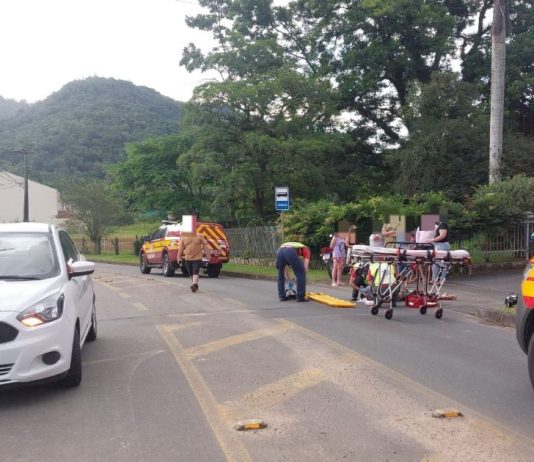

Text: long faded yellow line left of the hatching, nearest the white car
xmin=156 ymin=325 xmax=252 ymax=462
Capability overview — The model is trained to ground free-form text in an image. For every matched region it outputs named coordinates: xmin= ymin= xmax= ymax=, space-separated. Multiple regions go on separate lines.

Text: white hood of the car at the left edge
xmin=0 ymin=278 xmax=61 ymax=313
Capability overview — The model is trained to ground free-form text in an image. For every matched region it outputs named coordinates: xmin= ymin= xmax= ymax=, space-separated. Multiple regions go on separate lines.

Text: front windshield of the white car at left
xmin=0 ymin=232 xmax=59 ymax=280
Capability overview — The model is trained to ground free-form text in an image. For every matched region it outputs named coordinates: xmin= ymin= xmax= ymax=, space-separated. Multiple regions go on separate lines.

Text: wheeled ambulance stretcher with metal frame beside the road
xmin=349 ymin=242 xmax=471 ymax=319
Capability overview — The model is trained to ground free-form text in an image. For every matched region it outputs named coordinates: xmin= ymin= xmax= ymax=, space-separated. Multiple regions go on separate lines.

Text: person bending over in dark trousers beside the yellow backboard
xmin=276 ymin=242 xmax=311 ymax=302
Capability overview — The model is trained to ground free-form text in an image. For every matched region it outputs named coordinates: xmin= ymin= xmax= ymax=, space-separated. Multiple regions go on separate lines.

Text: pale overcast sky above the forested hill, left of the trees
xmin=0 ymin=0 xmax=220 ymax=102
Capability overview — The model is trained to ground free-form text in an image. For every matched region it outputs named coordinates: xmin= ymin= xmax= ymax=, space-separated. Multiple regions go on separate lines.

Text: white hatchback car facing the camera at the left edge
xmin=0 ymin=223 xmax=97 ymax=390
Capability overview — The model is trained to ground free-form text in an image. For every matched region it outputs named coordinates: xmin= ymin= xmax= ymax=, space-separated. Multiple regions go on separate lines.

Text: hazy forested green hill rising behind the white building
xmin=0 ymin=77 xmax=181 ymax=185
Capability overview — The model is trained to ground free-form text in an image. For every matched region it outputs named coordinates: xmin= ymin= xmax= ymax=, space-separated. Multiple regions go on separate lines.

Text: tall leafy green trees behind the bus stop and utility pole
xmin=111 ymin=0 xmax=534 ymax=224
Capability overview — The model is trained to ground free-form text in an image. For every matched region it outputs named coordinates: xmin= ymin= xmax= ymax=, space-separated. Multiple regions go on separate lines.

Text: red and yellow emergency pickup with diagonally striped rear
xmin=139 ymin=221 xmax=230 ymax=278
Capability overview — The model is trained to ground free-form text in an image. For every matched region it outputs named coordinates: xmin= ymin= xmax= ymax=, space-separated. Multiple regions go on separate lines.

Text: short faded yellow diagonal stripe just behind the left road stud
xmin=219 ymin=368 xmax=328 ymax=421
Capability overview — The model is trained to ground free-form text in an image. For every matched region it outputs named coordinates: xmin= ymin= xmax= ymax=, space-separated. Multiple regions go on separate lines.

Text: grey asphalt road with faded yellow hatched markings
xmin=0 ymin=264 xmax=534 ymax=461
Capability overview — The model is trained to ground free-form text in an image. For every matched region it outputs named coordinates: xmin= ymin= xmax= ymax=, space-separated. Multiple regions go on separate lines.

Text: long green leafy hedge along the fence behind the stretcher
xmin=283 ymin=175 xmax=534 ymax=252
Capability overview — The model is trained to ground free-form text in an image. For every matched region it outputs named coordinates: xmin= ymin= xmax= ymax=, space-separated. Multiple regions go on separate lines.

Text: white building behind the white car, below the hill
xmin=0 ymin=170 xmax=60 ymax=223
